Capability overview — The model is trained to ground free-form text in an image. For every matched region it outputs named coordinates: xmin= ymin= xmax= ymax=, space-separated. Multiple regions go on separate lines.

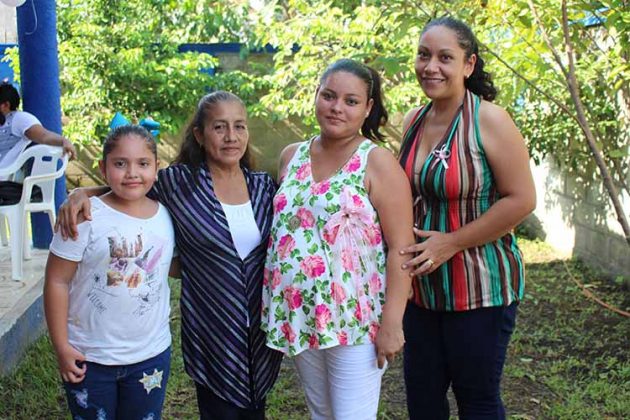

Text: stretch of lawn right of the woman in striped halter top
xmin=503 ymin=241 xmax=630 ymax=419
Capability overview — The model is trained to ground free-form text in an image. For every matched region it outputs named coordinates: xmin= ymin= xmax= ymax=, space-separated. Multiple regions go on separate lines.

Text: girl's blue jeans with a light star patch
xmin=63 ymin=347 xmax=171 ymax=420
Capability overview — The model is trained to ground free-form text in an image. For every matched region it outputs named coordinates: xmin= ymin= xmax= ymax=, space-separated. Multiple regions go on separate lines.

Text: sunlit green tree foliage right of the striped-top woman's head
xmin=477 ymin=0 xmax=630 ymax=190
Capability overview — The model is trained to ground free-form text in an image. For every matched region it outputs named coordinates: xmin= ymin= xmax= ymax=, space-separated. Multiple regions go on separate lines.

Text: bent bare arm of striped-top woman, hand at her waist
xmin=405 ymin=102 xmax=536 ymax=274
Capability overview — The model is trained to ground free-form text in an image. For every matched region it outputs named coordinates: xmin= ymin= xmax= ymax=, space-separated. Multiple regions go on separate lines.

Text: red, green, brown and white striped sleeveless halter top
xmin=399 ymin=91 xmax=525 ymax=311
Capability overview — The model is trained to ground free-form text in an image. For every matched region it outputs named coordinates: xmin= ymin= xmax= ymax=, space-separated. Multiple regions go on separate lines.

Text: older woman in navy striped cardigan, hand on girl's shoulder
xmin=60 ymin=91 xmax=282 ymax=419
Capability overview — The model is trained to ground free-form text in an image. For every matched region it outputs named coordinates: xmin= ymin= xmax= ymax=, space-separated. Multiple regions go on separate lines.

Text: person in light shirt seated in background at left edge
xmin=0 ymin=82 xmax=76 ymax=168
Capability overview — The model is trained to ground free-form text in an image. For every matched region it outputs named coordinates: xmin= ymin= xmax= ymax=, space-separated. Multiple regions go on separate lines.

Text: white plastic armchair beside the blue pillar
xmin=0 ymin=144 xmax=68 ymax=280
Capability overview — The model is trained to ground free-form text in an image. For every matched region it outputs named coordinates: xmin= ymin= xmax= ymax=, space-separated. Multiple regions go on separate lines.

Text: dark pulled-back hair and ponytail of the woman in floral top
xmin=319 ymin=58 xmax=388 ymax=141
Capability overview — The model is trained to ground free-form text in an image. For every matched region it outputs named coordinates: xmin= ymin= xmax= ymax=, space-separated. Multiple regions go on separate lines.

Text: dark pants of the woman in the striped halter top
xmin=404 ymin=303 xmax=517 ymax=420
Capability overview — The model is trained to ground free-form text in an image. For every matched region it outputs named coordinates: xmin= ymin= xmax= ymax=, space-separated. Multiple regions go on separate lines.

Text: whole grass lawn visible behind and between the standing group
xmin=0 ymin=240 xmax=630 ymax=419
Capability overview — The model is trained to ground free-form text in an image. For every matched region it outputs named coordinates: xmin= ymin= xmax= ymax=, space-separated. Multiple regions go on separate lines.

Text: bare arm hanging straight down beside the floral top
xmin=366 ymin=148 xmax=414 ymax=367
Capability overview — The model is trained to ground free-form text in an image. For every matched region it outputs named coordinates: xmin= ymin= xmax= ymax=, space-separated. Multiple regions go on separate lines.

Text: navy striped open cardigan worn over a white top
xmin=152 ymin=165 xmax=282 ymax=409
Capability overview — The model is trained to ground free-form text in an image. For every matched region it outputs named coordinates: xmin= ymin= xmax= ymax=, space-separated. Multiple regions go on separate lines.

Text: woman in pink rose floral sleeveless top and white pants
xmin=262 ymin=59 xmax=413 ymax=419
